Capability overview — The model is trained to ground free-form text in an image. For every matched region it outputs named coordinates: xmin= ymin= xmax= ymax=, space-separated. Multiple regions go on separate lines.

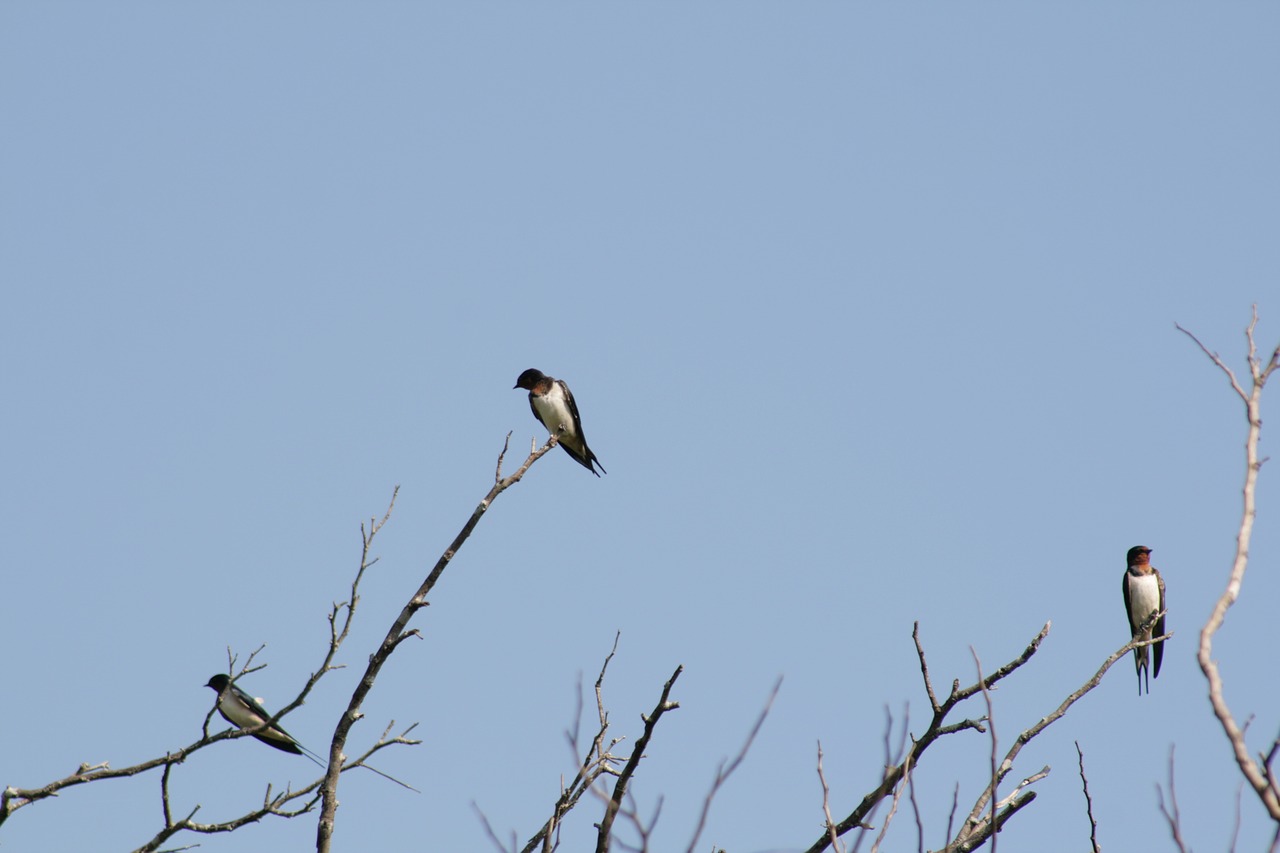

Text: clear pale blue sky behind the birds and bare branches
xmin=0 ymin=3 xmax=1280 ymax=853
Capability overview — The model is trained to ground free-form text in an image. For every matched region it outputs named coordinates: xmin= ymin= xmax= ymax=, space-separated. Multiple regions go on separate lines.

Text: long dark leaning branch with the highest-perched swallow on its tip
xmin=316 ymin=433 xmax=557 ymax=853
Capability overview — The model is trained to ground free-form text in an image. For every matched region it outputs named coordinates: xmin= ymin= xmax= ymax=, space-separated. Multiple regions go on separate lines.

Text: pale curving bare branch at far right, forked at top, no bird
xmin=1175 ymin=305 xmax=1280 ymax=824
